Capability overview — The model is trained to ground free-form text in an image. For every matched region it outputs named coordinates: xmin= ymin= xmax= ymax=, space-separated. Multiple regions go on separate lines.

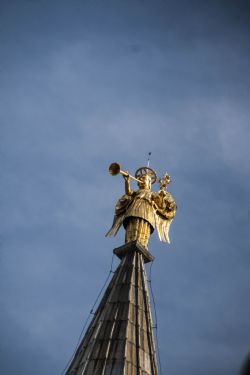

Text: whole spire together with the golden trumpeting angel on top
xmin=63 ymin=162 xmax=176 ymax=375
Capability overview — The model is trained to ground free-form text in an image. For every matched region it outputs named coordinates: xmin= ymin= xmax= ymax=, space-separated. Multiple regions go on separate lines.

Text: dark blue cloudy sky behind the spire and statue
xmin=0 ymin=0 xmax=250 ymax=375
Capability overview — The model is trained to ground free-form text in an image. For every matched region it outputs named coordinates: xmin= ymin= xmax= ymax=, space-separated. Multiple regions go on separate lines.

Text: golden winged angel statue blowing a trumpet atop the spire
xmin=106 ymin=163 xmax=176 ymax=248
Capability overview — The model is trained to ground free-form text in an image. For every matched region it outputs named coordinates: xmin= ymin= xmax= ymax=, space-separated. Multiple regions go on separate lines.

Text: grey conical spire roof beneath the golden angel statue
xmin=66 ymin=241 xmax=158 ymax=375
